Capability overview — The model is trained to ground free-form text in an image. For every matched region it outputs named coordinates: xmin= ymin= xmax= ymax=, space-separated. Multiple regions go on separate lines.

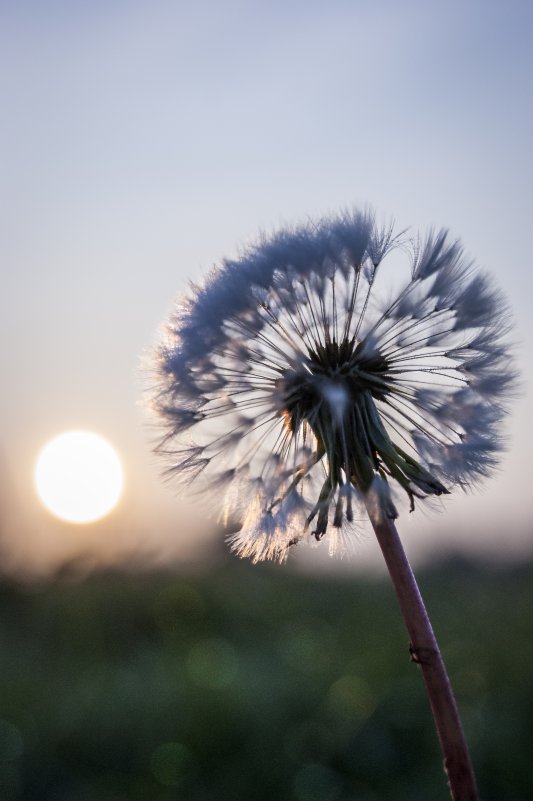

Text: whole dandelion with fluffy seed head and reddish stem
xmin=154 ymin=212 xmax=515 ymax=799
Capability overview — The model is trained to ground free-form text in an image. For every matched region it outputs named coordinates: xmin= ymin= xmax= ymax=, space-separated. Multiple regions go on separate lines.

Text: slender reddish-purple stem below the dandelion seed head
xmin=367 ymin=505 xmax=479 ymax=801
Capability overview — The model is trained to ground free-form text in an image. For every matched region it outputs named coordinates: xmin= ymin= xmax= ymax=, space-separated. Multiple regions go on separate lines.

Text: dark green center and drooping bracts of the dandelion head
xmin=277 ymin=332 xmax=447 ymax=539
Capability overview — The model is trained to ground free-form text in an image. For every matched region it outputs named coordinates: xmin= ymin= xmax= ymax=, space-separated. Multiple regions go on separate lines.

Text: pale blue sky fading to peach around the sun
xmin=0 ymin=0 xmax=533 ymax=573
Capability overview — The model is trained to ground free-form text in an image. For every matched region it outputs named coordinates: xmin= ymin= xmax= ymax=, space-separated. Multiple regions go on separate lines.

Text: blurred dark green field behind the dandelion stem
xmin=0 ymin=560 xmax=533 ymax=801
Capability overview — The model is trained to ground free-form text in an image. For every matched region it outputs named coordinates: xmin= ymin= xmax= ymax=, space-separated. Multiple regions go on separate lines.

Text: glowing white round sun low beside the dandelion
xmin=35 ymin=431 xmax=124 ymax=523
